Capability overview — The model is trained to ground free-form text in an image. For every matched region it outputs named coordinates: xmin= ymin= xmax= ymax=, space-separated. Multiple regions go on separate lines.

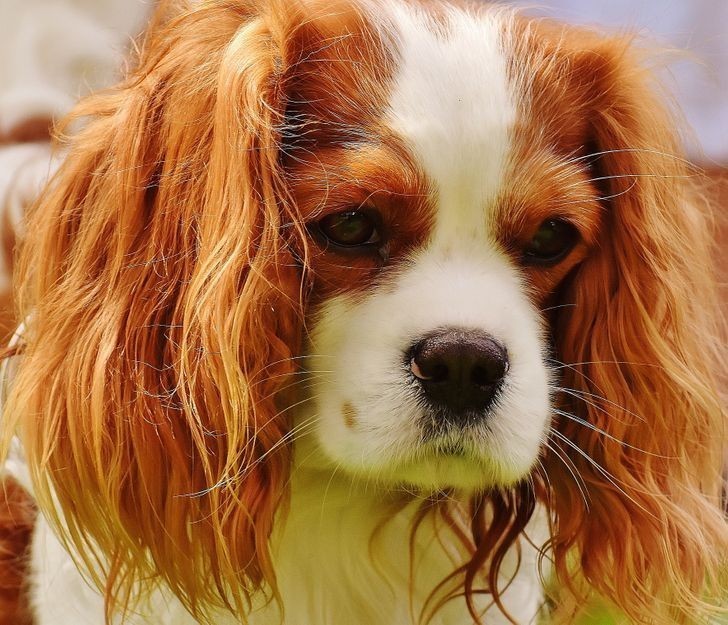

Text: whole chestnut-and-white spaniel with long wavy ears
xmin=3 ymin=0 xmax=728 ymax=625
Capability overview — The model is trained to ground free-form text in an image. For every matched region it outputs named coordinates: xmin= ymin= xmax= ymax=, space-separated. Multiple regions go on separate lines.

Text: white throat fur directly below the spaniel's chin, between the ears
xmin=253 ymin=454 xmax=541 ymax=625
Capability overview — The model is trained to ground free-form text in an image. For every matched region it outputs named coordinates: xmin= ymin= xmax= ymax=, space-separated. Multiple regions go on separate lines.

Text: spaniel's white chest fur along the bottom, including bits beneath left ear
xmin=25 ymin=466 xmax=542 ymax=625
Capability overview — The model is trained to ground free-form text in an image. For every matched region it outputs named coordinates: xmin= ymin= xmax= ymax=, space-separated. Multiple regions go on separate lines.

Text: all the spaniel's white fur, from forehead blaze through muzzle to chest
xmin=1 ymin=5 xmax=550 ymax=625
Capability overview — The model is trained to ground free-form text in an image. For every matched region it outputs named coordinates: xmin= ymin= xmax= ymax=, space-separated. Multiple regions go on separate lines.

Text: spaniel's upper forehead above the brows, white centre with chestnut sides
xmin=285 ymin=0 xmax=603 ymax=184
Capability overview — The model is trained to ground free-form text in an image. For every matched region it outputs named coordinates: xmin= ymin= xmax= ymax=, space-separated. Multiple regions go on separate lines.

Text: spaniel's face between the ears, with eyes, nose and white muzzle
xmin=291 ymin=5 xmax=603 ymax=489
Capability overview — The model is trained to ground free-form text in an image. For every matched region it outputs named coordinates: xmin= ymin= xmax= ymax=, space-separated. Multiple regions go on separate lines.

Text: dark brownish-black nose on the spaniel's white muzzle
xmin=409 ymin=328 xmax=508 ymax=416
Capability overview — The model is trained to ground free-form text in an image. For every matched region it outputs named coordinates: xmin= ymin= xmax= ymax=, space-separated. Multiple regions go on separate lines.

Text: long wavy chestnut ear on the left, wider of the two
xmin=5 ymin=1 xmax=316 ymax=617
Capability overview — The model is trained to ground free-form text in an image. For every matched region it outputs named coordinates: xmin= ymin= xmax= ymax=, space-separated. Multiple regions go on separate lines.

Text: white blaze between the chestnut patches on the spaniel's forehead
xmin=388 ymin=3 xmax=516 ymax=244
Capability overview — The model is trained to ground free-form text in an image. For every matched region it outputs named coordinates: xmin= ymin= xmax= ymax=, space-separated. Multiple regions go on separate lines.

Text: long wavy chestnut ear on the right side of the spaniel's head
xmin=550 ymin=37 xmax=728 ymax=623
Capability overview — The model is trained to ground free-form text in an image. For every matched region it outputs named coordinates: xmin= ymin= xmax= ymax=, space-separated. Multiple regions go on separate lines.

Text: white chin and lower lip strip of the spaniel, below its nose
xmin=295 ymin=400 xmax=543 ymax=496
